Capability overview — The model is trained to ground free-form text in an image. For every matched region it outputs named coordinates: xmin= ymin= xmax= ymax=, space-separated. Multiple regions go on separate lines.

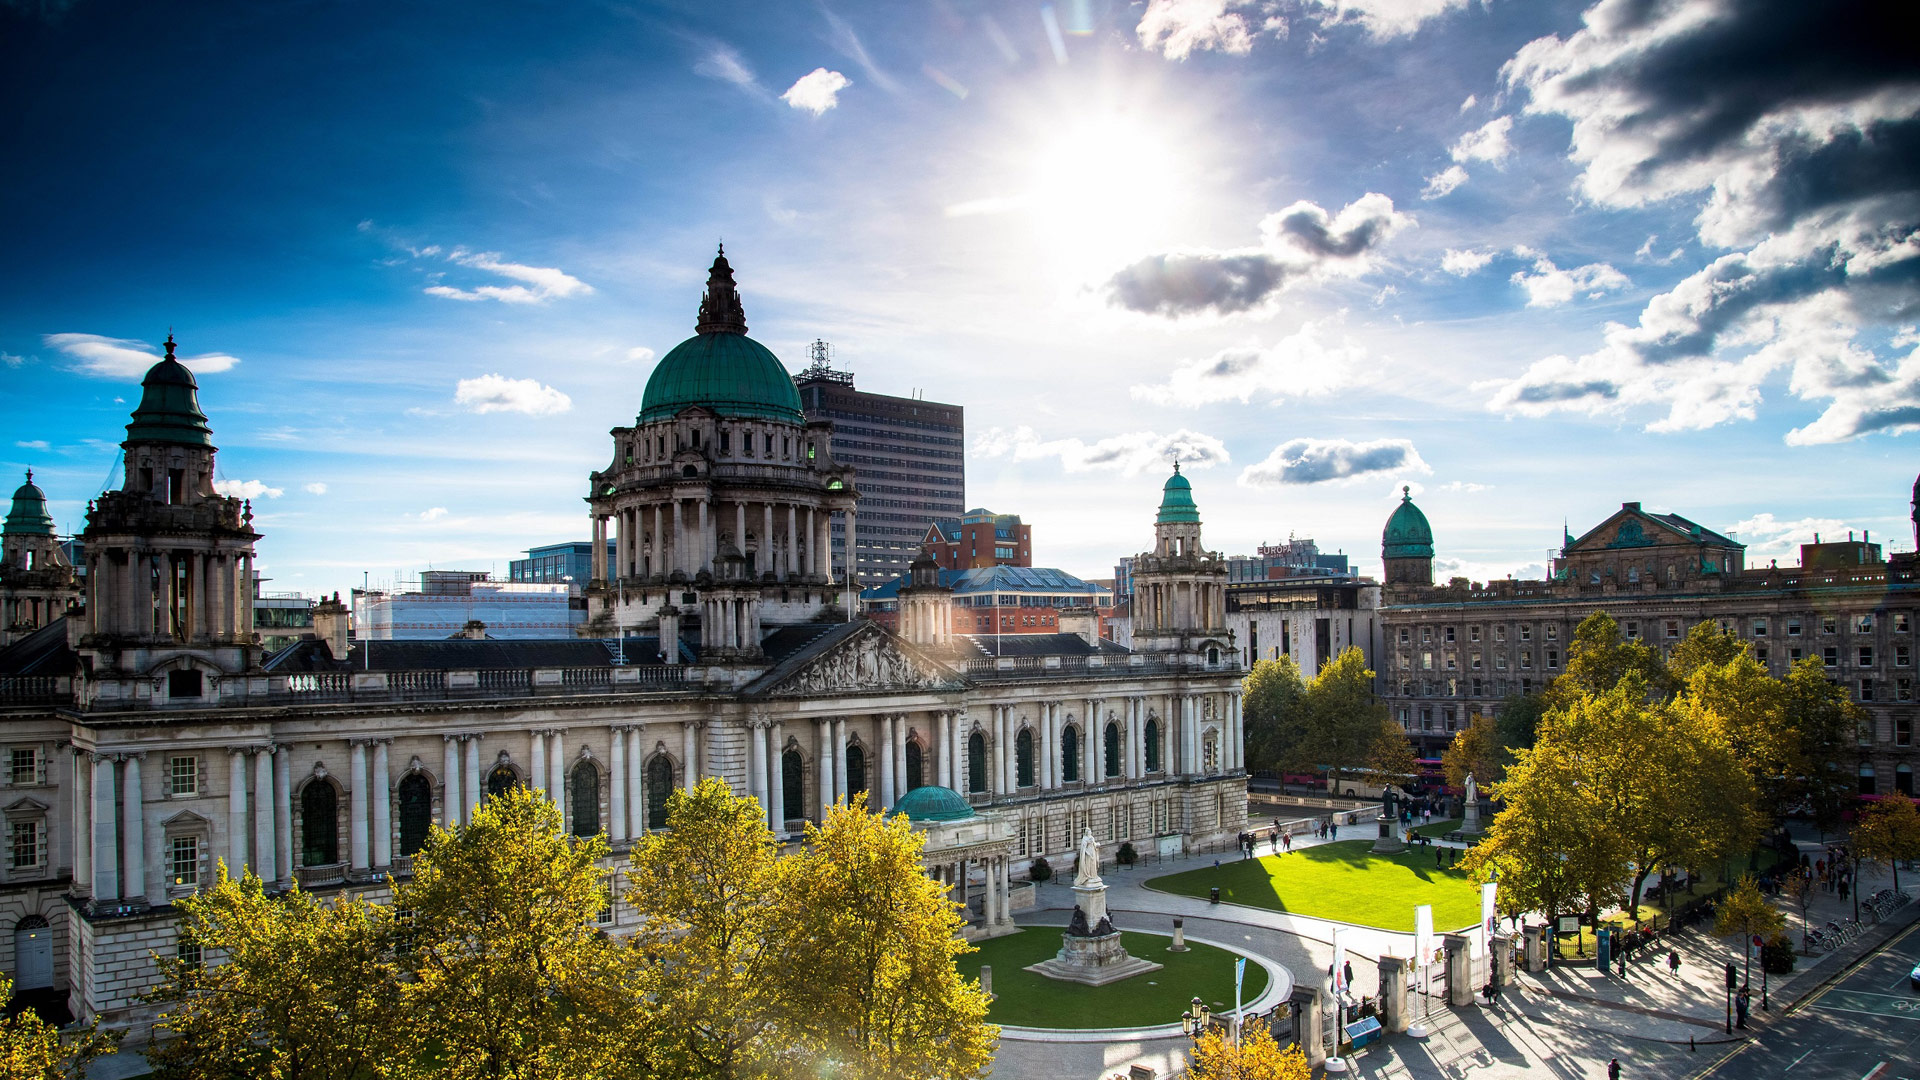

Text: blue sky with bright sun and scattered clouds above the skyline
xmin=0 ymin=0 xmax=1920 ymax=594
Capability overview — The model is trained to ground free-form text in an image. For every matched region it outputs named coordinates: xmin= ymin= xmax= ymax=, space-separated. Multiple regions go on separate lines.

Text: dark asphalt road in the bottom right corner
xmin=1695 ymin=922 xmax=1920 ymax=1080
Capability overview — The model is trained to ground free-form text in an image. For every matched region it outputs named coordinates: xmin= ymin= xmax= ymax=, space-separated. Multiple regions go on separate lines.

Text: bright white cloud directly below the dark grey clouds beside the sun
xmin=1133 ymin=323 xmax=1367 ymax=405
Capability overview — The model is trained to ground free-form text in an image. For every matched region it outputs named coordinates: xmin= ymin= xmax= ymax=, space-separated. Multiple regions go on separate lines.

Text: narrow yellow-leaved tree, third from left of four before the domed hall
xmin=624 ymin=776 xmax=787 ymax=1078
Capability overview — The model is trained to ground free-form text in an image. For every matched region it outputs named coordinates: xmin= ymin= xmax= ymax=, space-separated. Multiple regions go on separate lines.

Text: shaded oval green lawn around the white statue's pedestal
xmin=960 ymin=926 xmax=1267 ymax=1028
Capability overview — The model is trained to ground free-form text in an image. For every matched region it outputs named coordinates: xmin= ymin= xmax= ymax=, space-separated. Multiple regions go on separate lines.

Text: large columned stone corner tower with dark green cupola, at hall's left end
xmin=81 ymin=334 xmax=259 ymax=707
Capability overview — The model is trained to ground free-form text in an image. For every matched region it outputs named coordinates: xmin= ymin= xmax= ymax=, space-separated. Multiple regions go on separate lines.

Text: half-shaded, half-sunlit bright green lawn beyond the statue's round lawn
xmin=1146 ymin=840 xmax=1480 ymax=934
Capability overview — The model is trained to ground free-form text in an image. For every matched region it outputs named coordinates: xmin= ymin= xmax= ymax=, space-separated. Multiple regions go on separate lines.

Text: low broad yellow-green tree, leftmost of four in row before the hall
xmin=146 ymin=865 xmax=397 ymax=1080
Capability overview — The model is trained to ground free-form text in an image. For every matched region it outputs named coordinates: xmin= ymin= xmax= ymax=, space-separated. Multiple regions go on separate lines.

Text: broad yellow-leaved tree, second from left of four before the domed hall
xmin=394 ymin=786 xmax=649 ymax=1080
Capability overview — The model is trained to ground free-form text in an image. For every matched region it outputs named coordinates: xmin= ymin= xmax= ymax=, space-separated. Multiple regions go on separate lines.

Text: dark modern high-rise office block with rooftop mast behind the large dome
xmin=793 ymin=340 xmax=966 ymax=586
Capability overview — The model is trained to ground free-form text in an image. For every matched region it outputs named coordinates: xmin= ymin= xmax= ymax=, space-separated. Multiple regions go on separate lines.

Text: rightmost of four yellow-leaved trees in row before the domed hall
xmin=774 ymin=803 xmax=998 ymax=1080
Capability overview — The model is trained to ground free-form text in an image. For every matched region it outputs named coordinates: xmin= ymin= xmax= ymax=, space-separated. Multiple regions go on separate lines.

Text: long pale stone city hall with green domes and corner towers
xmin=0 ymin=256 xmax=1246 ymax=1026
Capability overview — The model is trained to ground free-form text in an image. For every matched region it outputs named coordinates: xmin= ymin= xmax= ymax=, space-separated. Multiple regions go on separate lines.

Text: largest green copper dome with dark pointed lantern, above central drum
xmin=639 ymin=248 xmax=806 ymax=425
